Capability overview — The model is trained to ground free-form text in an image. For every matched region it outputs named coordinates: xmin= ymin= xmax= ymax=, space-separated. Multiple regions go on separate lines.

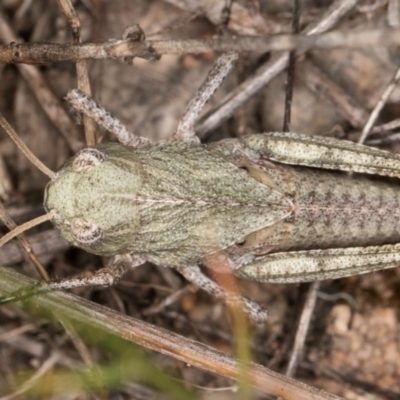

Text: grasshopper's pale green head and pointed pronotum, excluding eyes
xmin=44 ymin=140 xmax=291 ymax=267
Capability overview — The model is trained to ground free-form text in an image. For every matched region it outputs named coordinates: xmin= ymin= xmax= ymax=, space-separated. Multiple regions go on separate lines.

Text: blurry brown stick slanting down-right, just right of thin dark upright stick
xmin=298 ymin=58 xmax=368 ymax=129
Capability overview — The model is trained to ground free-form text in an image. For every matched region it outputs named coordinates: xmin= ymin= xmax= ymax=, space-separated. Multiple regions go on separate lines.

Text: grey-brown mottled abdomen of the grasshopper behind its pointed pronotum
xmin=253 ymin=165 xmax=400 ymax=252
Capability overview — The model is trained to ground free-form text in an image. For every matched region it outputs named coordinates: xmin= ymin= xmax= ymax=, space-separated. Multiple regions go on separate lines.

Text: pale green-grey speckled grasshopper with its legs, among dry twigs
xmin=0 ymin=53 xmax=400 ymax=321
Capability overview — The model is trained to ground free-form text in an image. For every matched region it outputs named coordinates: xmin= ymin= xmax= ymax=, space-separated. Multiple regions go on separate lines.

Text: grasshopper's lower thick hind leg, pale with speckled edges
xmin=235 ymin=244 xmax=400 ymax=283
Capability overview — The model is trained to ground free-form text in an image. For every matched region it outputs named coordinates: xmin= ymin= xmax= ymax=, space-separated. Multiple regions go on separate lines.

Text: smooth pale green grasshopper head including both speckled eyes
xmin=44 ymin=143 xmax=142 ymax=255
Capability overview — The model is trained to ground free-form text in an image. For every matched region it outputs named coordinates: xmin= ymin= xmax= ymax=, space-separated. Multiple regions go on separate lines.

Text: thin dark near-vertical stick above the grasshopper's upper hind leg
xmin=282 ymin=0 xmax=301 ymax=132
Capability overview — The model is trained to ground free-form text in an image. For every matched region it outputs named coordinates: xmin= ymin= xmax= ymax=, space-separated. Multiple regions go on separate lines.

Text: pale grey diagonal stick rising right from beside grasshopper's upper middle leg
xmin=196 ymin=0 xmax=360 ymax=137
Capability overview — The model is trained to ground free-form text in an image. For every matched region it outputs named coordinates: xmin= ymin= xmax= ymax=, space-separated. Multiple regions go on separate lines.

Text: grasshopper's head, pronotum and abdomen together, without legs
xmin=45 ymin=136 xmax=400 ymax=267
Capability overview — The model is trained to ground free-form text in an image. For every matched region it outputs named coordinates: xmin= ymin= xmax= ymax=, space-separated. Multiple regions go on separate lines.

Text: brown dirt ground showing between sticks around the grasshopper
xmin=0 ymin=0 xmax=400 ymax=400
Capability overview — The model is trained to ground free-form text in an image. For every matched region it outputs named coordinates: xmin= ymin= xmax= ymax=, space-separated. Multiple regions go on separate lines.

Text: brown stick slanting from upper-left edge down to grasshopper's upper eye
xmin=0 ymin=8 xmax=83 ymax=152
